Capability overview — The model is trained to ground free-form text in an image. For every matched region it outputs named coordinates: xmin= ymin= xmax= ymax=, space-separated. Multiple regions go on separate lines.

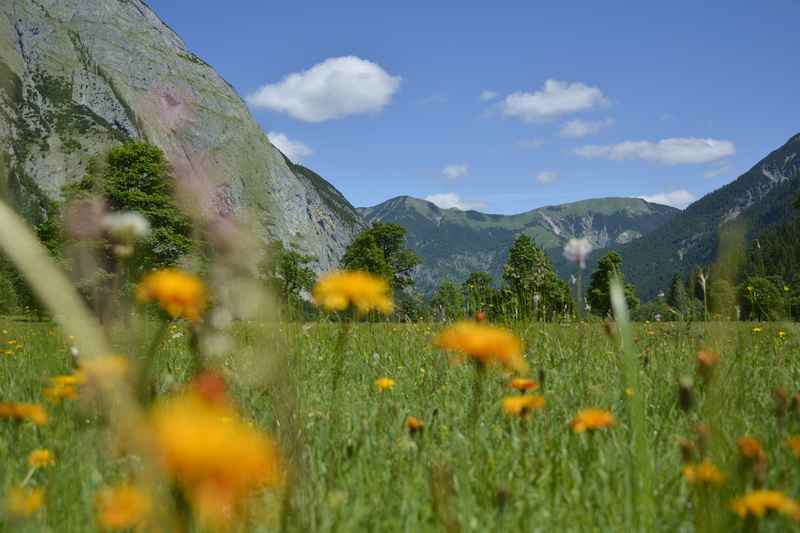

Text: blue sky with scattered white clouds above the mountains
xmin=149 ymin=0 xmax=800 ymax=213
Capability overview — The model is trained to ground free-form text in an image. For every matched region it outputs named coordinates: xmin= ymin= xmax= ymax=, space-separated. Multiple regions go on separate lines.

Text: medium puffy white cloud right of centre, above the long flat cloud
xmin=502 ymin=80 xmax=608 ymax=122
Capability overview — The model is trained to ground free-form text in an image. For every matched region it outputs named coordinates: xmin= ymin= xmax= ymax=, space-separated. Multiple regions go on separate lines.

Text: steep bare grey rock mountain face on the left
xmin=0 ymin=0 xmax=362 ymax=269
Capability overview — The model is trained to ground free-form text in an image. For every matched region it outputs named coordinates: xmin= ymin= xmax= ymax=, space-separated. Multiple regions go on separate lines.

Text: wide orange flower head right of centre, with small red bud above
xmin=434 ymin=321 xmax=528 ymax=373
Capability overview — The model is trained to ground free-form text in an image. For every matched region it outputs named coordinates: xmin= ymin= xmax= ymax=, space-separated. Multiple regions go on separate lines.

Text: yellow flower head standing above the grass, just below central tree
xmin=313 ymin=272 xmax=394 ymax=315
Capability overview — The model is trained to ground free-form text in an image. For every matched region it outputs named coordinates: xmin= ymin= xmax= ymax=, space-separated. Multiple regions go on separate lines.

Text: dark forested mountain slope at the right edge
xmin=617 ymin=134 xmax=800 ymax=298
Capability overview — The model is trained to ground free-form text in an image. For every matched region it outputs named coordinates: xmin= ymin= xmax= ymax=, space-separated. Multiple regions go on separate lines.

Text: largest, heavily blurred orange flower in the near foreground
xmin=152 ymin=393 xmax=284 ymax=527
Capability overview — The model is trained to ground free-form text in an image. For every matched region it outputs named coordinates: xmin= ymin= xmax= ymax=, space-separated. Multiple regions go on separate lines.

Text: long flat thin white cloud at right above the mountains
xmin=575 ymin=137 xmax=736 ymax=165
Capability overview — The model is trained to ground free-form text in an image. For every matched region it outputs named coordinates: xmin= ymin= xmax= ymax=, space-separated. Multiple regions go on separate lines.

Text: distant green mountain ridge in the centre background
xmin=359 ymin=196 xmax=679 ymax=293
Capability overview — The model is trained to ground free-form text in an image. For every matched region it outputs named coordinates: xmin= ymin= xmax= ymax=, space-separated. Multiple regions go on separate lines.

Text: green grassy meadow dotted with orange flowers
xmin=0 ymin=319 xmax=800 ymax=532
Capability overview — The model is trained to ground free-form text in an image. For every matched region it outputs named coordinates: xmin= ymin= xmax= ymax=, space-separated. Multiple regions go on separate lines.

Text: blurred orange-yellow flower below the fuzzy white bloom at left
xmin=136 ymin=269 xmax=206 ymax=322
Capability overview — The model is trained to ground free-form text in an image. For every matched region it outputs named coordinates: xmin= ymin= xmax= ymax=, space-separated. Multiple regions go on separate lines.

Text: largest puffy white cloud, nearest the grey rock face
xmin=247 ymin=56 xmax=400 ymax=122
